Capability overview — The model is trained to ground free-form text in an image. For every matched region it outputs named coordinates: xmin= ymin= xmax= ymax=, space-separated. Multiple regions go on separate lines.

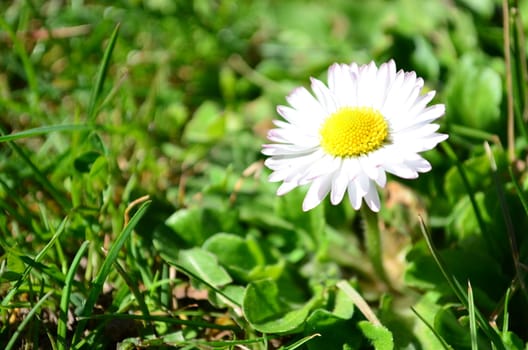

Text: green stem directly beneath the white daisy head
xmin=360 ymin=206 xmax=391 ymax=287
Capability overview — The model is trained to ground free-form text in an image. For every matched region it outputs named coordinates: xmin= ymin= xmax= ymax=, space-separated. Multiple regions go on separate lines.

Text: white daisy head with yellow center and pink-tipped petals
xmin=262 ymin=60 xmax=447 ymax=211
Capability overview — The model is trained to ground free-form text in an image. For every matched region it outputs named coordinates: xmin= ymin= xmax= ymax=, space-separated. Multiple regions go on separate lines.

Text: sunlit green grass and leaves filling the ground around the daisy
xmin=0 ymin=0 xmax=528 ymax=350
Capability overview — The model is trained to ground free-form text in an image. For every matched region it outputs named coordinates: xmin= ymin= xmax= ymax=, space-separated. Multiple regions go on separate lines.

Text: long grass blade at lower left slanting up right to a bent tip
xmin=72 ymin=201 xmax=151 ymax=348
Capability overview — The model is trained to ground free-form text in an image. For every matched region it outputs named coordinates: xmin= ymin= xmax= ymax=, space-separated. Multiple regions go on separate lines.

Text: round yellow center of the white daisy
xmin=319 ymin=107 xmax=389 ymax=157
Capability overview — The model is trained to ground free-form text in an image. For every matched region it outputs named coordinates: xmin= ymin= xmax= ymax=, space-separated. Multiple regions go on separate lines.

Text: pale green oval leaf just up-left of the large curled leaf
xmin=178 ymin=248 xmax=232 ymax=287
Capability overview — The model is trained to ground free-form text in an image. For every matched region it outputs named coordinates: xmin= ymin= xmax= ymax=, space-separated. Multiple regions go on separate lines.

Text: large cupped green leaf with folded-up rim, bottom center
xmin=242 ymin=279 xmax=319 ymax=333
